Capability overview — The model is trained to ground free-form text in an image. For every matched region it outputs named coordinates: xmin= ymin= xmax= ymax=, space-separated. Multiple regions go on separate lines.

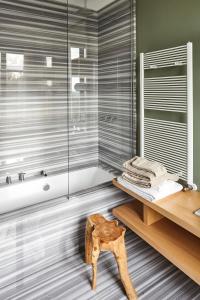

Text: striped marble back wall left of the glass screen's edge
xmin=0 ymin=0 xmax=68 ymax=195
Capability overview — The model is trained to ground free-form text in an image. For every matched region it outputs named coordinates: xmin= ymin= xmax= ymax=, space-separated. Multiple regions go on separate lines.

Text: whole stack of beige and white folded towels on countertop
xmin=118 ymin=156 xmax=183 ymax=201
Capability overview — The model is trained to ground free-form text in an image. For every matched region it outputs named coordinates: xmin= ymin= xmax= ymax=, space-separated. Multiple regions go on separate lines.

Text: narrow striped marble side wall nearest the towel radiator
xmin=98 ymin=0 xmax=136 ymax=168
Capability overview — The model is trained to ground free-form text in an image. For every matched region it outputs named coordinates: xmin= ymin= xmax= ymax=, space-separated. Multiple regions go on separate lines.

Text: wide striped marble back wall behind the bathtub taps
xmin=0 ymin=0 xmax=98 ymax=181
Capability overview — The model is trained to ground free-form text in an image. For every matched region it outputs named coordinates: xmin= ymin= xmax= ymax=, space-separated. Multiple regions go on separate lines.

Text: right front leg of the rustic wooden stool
xmin=114 ymin=237 xmax=137 ymax=300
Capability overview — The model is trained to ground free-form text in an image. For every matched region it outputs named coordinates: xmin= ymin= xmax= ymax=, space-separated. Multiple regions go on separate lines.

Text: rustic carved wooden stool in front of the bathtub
xmin=85 ymin=214 xmax=137 ymax=300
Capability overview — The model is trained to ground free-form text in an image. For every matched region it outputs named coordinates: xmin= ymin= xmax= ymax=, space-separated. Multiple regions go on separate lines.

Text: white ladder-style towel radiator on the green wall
xmin=140 ymin=42 xmax=193 ymax=184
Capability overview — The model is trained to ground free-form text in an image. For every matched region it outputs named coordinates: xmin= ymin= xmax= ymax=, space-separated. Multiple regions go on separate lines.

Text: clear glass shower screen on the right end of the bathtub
xmin=68 ymin=0 xmax=136 ymax=194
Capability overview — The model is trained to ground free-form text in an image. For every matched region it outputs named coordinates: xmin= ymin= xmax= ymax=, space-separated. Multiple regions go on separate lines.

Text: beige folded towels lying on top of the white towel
xmin=122 ymin=156 xmax=179 ymax=187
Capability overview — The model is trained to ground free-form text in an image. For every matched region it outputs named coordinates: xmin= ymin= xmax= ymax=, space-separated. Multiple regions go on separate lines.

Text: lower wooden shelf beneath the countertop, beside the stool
xmin=113 ymin=200 xmax=200 ymax=284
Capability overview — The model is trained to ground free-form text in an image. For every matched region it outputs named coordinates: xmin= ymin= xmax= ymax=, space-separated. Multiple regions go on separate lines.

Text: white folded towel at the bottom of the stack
xmin=117 ymin=177 xmax=183 ymax=201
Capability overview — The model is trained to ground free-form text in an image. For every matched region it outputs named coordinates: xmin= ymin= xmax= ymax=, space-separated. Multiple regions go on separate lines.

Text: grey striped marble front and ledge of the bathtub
xmin=0 ymin=185 xmax=133 ymax=292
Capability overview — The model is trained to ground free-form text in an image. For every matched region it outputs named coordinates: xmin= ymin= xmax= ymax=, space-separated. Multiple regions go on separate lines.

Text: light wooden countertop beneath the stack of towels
xmin=113 ymin=179 xmax=200 ymax=237
